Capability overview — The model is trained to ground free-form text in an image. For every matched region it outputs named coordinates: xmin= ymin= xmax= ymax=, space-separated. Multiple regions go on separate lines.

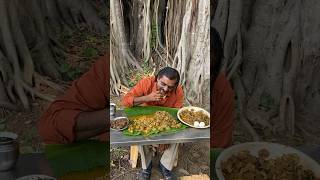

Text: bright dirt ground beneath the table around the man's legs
xmin=110 ymin=142 xmax=210 ymax=180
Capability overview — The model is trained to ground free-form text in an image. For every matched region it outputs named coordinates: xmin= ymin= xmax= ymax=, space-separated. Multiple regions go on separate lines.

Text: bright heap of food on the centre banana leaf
xmin=128 ymin=111 xmax=182 ymax=135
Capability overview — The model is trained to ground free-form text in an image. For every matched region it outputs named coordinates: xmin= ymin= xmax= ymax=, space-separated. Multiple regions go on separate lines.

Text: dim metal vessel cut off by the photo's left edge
xmin=0 ymin=132 xmax=19 ymax=171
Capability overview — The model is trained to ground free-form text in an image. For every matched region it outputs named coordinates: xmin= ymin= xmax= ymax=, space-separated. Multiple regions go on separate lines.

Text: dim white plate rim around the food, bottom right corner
xmin=215 ymin=142 xmax=320 ymax=180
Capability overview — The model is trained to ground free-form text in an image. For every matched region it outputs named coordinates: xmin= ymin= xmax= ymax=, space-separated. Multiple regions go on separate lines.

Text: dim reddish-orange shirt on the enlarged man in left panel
xmin=38 ymin=55 xmax=110 ymax=144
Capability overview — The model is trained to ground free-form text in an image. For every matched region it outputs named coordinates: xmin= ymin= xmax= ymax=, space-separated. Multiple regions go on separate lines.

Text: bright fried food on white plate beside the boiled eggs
xmin=179 ymin=109 xmax=210 ymax=126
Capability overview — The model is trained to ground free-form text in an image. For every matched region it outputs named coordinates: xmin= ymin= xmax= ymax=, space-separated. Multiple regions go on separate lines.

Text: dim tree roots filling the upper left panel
xmin=0 ymin=0 xmax=107 ymax=110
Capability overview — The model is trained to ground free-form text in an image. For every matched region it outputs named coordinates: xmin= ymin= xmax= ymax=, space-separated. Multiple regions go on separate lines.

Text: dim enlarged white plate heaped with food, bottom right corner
xmin=215 ymin=142 xmax=320 ymax=180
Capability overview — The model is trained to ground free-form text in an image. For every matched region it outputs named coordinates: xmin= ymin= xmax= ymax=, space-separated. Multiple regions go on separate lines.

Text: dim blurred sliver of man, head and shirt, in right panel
xmin=210 ymin=28 xmax=235 ymax=148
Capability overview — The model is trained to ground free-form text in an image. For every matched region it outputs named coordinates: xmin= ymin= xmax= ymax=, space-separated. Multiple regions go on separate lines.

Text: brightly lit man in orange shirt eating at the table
xmin=122 ymin=67 xmax=183 ymax=180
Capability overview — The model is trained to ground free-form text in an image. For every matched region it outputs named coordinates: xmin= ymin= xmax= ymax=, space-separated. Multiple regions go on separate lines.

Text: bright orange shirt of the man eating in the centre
xmin=122 ymin=76 xmax=183 ymax=108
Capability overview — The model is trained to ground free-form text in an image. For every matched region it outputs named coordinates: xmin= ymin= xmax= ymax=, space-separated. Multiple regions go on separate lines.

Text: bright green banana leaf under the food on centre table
xmin=123 ymin=106 xmax=188 ymax=136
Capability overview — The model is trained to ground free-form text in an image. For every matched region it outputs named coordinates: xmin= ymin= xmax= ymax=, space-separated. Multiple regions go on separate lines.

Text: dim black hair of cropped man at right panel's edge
xmin=210 ymin=26 xmax=223 ymax=87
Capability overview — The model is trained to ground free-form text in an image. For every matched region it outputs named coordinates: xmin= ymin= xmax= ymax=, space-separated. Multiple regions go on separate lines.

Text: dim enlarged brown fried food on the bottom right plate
xmin=221 ymin=149 xmax=319 ymax=180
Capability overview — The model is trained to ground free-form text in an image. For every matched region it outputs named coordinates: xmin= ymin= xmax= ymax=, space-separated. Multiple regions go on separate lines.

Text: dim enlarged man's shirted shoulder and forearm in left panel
xmin=38 ymin=54 xmax=110 ymax=144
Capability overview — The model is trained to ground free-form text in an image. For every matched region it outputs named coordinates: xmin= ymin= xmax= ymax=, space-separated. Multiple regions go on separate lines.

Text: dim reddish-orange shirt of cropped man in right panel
xmin=210 ymin=74 xmax=235 ymax=148
